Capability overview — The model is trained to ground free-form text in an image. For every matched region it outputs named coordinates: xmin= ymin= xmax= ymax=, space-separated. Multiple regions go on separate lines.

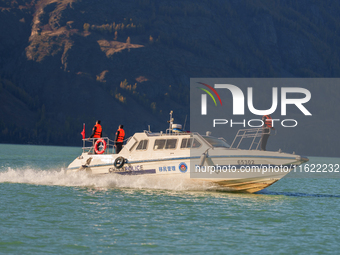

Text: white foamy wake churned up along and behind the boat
xmin=0 ymin=167 xmax=217 ymax=191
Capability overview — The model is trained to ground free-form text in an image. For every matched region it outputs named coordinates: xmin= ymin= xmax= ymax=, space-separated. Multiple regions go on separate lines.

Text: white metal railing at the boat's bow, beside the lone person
xmin=230 ymin=128 xmax=263 ymax=150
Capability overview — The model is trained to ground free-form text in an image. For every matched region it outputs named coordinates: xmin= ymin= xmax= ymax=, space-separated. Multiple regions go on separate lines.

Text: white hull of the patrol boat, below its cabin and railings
xmin=67 ymin=150 xmax=308 ymax=193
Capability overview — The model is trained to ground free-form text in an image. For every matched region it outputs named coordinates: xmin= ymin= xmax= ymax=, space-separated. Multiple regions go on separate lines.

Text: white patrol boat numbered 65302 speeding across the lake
xmin=66 ymin=111 xmax=308 ymax=193
